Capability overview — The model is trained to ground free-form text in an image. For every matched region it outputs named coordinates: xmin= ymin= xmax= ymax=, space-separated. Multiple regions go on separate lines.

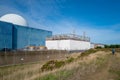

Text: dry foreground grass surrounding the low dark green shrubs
xmin=0 ymin=50 xmax=120 ymax=80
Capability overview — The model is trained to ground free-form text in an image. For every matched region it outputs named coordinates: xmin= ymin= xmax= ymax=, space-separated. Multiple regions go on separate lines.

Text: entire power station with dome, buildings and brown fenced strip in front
xmin=0 ymin=14 xmax=103 ymax=65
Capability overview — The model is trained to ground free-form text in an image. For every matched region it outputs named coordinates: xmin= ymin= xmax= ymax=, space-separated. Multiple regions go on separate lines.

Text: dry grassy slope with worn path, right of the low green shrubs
xmin=36 ymin=48 xmax=120 ymax=80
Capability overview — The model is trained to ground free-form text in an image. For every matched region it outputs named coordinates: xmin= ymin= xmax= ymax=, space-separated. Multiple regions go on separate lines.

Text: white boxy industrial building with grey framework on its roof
xmin=46 ymin=34 xmax=90 ymax=51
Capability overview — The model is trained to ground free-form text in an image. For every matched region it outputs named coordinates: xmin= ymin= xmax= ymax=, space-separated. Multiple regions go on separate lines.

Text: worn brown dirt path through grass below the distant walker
xmin=80 ymin=54 xmax=120 ymax=80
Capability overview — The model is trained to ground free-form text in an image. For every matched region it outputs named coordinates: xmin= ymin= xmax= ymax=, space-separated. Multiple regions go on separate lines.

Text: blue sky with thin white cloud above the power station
xmin=0 ymin=0 xmax=120 ymax=44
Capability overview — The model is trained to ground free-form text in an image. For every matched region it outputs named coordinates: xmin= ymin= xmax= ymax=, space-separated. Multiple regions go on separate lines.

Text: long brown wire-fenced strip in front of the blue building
xmin=0 ymin=50 xmax=69 ymax=66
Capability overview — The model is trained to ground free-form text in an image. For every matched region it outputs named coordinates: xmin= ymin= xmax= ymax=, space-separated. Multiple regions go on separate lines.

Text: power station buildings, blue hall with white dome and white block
xmin=0 ymin=14 xmax=101 ymax=51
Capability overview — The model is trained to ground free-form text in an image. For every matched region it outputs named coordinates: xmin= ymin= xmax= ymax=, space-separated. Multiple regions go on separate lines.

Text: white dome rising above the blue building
xmin=0 ymin=14 xmax=27 ymax=26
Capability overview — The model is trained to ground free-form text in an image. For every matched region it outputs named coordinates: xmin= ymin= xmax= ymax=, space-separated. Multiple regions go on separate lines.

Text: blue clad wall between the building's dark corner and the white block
xmin=14 ymin=25 xmax=52 ymax=49
